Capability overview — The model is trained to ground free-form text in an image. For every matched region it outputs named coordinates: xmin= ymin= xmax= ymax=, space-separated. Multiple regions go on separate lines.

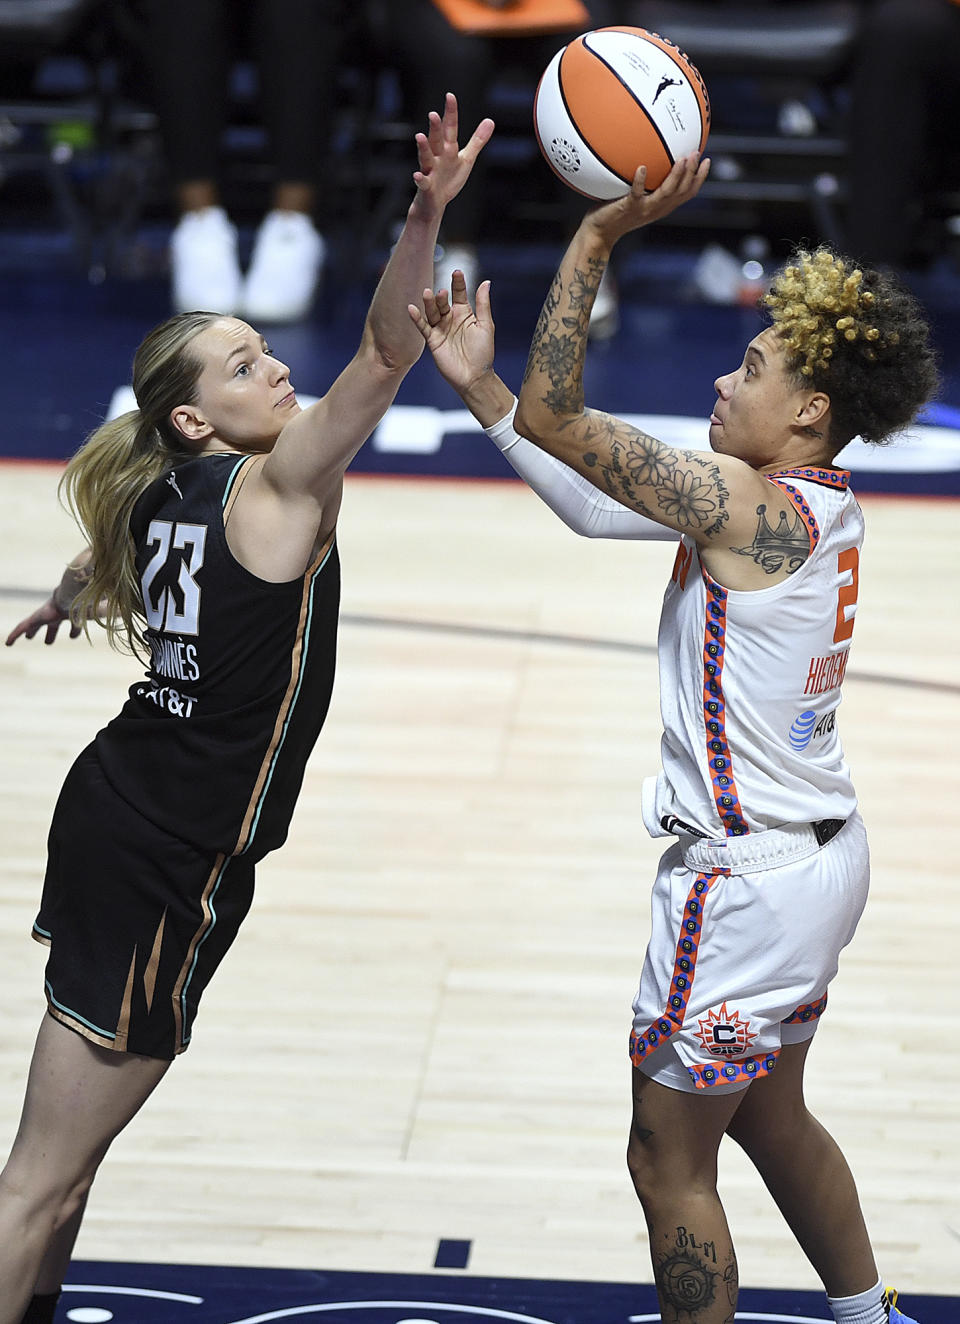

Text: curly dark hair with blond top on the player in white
xmin=763 ymin=245 xmax=937 ymax=450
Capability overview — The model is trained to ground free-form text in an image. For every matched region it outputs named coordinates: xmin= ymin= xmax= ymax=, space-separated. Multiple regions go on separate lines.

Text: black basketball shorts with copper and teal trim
xmin=33 ymin=747 xmax=254 ymax=1059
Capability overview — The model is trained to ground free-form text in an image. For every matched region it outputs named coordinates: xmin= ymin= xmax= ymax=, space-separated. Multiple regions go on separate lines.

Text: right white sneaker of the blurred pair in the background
xmin=242 ymin=212 xmax=327 ymax=324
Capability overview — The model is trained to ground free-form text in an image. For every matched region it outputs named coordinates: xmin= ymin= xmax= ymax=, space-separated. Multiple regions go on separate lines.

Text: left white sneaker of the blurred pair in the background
xmin=169 ymin=207 xmax=242 ymax=314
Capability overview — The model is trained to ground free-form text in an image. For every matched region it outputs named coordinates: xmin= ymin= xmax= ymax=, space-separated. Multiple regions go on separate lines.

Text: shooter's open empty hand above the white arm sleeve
xmin=408 ymin=270 xmax=494 ymax=396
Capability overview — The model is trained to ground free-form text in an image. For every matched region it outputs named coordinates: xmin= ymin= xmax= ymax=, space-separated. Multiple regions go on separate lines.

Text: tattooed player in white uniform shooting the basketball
xmin=410 ymin=156 xmax=936 ymax=1324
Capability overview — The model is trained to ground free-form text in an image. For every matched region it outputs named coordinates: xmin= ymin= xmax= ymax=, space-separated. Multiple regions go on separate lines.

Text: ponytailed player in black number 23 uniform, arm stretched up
xmin=0 ymin=93 xmax=494 ymax=1324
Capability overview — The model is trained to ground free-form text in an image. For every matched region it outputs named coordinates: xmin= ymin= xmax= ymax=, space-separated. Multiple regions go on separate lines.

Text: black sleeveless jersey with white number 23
xmin=94 ymin=454 xmax=340 ymax=859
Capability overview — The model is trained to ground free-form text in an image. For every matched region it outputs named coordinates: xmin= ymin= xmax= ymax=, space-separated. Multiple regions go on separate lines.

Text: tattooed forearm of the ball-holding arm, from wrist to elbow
xmin=516 ymin=218 xmax=609 ymax=459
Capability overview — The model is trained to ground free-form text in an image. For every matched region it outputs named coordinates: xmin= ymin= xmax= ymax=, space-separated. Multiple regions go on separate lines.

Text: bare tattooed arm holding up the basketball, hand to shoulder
xmin=515 ymin=156 xmax=760 ymax=543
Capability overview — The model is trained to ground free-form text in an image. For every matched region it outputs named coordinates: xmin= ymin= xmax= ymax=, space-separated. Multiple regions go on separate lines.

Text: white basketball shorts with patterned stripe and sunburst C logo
xmin=630 ymin=813 xmax=870 ymax=1094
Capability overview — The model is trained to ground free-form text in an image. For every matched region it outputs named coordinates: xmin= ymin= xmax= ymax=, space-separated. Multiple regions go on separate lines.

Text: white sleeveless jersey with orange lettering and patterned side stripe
xmin=644 ymin=469 xmax=863 ymax=838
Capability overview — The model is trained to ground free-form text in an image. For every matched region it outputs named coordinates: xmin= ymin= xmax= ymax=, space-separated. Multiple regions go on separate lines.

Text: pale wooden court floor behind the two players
xmin=0 ymin=462 xmax=960 ymax=1295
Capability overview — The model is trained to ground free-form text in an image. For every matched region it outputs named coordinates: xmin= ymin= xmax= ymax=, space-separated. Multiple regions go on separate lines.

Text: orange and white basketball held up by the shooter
xmin=534 ymin=26 xmax=710 ymax=201
